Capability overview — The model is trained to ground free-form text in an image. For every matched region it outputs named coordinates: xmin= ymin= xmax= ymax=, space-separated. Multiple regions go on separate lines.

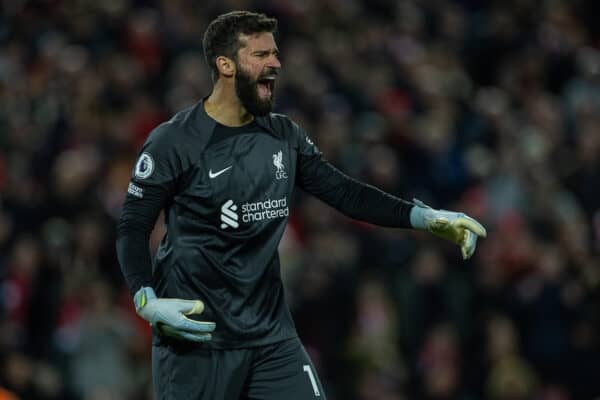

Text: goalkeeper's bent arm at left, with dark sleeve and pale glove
xmin=116 ymin=127 xmax=215 ymax=342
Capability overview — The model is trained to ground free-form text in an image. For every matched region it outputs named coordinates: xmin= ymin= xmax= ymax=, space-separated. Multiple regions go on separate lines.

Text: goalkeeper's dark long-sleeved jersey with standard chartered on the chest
xmin=117 ymin=101 xmax=412 ymax=348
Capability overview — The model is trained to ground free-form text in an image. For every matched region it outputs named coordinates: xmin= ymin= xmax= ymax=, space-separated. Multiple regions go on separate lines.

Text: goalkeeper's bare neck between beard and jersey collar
xmin=204 ymin=78 xmax=254 ymax=126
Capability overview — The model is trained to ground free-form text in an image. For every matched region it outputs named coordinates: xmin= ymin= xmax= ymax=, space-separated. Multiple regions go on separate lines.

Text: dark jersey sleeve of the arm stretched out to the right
xmin=292 ymin=123 xmax=413 ymax=228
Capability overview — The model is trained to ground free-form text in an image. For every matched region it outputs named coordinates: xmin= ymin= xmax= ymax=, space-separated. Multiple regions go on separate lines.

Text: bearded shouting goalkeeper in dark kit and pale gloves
xmin=117 ymin=11 xmax=486 ymax=400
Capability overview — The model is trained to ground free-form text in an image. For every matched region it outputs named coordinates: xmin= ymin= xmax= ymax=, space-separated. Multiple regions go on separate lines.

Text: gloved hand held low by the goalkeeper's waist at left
xmin=133 ymin=287 xmax=215 ymax=342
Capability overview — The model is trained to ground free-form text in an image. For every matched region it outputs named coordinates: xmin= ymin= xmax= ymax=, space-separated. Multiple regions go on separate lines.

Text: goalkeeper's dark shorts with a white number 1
xmin=152 ymin=338 xmax=325 ymax=400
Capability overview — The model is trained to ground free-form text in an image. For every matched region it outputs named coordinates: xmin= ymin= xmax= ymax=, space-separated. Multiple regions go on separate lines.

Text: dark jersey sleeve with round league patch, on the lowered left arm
xmin=116 ymin=127 xmax=182 ymax=294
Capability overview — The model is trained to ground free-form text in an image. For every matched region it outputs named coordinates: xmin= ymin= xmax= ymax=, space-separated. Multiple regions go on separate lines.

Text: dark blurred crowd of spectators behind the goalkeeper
xmin=0 ymin=0 xmax=600 ymax=400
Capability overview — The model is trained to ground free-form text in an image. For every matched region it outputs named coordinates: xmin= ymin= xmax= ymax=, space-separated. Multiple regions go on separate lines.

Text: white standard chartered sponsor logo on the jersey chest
xmin=221 ymin=197 xmax=290 ymax=229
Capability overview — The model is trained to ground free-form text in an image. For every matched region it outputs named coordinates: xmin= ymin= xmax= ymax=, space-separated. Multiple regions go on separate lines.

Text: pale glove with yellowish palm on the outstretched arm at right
xmin=410 ymin=199 xmax=487 ymax=260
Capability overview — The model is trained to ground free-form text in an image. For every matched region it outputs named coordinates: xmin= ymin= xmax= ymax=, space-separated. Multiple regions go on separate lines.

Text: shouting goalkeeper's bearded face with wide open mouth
xmin=235 ymin=32 xmax=281 ymax=116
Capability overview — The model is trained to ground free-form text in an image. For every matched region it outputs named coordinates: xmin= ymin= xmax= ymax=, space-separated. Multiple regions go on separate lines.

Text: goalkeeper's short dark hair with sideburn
xmin=202 ymin=11 xmax=277 ymax=82
